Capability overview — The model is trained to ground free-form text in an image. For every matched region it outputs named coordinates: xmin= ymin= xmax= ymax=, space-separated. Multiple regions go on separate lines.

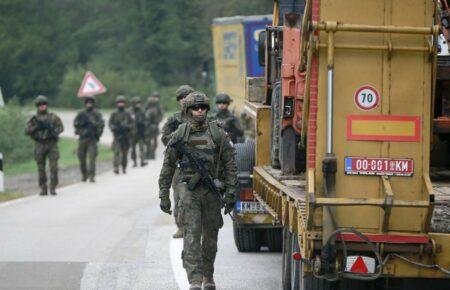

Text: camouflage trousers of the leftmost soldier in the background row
xmin=34 ymin=140 xmax=59 ymax=189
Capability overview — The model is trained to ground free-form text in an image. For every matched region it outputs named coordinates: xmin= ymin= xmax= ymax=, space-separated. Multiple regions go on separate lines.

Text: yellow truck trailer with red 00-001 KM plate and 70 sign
xmin=245 ymin=0 xmax=450 ymax=289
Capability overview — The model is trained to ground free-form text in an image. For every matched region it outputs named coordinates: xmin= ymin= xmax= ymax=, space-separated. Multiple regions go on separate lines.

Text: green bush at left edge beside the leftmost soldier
xmin=0 ymin=102 xmax=33 ymax=166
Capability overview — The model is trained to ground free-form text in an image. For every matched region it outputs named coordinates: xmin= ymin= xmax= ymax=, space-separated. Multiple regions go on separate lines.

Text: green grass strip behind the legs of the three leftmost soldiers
xmin=3 ymin=138 xmax=113 ymax=176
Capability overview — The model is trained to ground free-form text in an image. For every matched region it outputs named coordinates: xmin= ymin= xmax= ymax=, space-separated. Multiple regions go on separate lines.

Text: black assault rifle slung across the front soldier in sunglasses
xmin=170 ymin=140 xmax=235 ymax=221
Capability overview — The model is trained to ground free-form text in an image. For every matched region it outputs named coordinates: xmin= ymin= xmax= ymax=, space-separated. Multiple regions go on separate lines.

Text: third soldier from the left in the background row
xmin=109 ymin=96 xmax=134 ymax=174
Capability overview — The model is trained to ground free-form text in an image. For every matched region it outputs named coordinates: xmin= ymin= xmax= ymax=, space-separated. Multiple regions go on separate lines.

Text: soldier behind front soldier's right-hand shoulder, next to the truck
xmin=215 ymin=93 xmax=244 ymax=143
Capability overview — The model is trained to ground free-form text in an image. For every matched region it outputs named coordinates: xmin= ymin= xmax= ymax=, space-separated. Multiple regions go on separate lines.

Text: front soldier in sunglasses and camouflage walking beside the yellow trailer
xmin=159 ymin=92 xmax=237 ymax=290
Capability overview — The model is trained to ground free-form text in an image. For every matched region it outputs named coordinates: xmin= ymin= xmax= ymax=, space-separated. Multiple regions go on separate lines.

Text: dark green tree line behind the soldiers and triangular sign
xmin=0 ymin=0 xmax=273 ymax=107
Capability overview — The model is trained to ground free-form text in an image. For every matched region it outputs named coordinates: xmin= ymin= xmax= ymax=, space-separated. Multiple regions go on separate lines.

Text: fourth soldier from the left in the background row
xmin=130 ymin=97 xmax=147 ymax=167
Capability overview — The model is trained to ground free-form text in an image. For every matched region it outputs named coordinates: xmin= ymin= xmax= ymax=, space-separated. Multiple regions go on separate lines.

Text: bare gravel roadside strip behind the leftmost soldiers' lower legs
xmin=5 ymin=161 xmax=112 ymax=195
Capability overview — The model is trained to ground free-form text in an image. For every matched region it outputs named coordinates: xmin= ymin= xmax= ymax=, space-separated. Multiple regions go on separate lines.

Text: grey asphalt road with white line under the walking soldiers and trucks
xmin=0 ymin=110 xmax=281 ymax=290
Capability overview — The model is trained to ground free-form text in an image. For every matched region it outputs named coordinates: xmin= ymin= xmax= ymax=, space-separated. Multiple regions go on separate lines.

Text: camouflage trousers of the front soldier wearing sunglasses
xmin=178 ymin=183 xmax=223 ymax=283
